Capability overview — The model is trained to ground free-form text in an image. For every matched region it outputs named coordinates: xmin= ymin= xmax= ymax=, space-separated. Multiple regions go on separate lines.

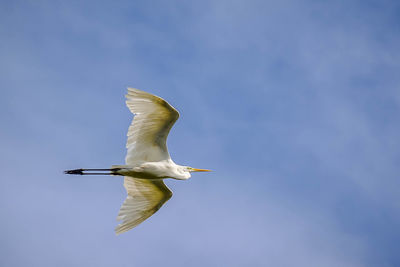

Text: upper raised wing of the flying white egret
xmin=125 ymin=88 xmax=179 ymax=164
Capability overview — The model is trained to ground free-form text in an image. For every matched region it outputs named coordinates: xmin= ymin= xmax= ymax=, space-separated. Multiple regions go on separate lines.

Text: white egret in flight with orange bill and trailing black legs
xmin=65 ymin=88 xmax=209 ymax=235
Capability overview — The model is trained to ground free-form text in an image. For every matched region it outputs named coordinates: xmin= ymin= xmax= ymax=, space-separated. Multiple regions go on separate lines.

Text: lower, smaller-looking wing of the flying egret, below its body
xmin=115 ymin=176 xmax=172 ymax=235
